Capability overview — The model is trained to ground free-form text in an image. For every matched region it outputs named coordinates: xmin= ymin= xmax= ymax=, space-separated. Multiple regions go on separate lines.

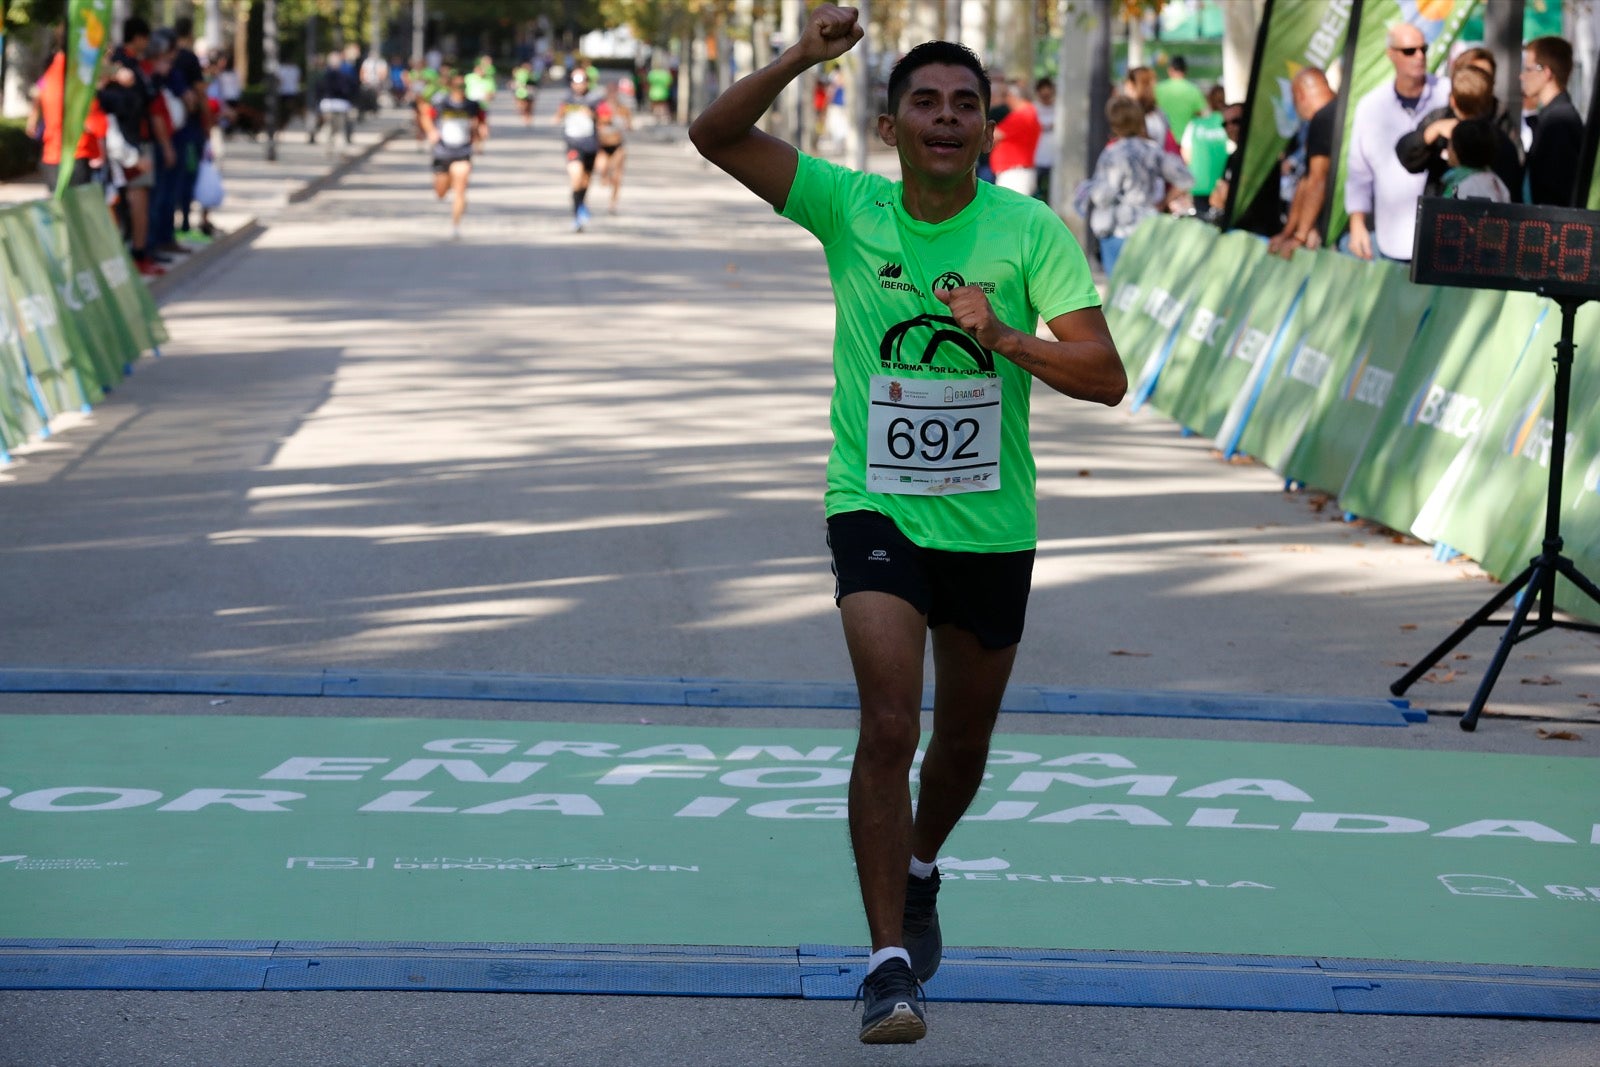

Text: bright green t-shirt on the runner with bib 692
xmin=781 ymin=155 xmax=1099 ymax=552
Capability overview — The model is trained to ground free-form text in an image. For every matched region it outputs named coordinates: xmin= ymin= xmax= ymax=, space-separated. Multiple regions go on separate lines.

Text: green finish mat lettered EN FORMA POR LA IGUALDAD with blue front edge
xmin=0 ymin=715 xmax=1600 ymax=1017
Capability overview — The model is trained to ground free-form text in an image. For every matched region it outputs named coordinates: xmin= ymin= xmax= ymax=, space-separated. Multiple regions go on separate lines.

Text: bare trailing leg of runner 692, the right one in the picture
xmin=901 ymin=625 xmax=1016 ymax=863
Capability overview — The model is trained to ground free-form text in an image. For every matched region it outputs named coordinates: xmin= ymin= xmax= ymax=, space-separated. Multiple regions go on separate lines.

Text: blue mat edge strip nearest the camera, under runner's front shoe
xmin=0 ymin=939 xmax=1600 ymax=1022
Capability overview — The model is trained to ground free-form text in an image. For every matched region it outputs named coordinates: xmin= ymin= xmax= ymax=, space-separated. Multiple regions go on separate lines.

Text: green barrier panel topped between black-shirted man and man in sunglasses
xmin=1222 ymin=251 xmax=1387 ymax=474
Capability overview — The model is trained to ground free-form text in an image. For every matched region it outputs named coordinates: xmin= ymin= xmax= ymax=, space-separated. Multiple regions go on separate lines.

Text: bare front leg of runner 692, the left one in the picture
xmin=838 ymin=592 xmax=928 ymax=952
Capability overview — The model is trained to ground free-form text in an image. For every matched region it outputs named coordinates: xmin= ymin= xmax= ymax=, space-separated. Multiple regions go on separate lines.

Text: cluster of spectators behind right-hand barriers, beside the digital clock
xmin=1074 ymin=22 xmax=1584 ymax=272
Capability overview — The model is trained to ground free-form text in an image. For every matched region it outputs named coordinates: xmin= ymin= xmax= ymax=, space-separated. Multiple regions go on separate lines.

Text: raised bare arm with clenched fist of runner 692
xmin=690 ymin=3 xmax=862 ymax=210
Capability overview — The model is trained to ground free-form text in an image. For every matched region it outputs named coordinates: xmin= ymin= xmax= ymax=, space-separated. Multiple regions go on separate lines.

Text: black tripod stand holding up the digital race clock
xmin=1389 ymin=296 xmax=1600 ymax=731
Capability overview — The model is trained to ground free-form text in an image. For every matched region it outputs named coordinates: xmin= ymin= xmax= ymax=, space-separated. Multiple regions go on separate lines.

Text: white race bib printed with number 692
xmin=867 ymin=374 xmax=1000 ymax=496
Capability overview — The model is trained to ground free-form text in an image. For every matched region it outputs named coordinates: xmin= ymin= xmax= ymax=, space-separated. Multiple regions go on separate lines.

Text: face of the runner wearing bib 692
xmin=878 ymin=62 xmax=994 ymax=179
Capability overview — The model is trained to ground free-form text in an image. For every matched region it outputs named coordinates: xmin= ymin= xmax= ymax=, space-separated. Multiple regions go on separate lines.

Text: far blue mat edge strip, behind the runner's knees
xmin=0 ymin=667 xmax=1427 ymax=726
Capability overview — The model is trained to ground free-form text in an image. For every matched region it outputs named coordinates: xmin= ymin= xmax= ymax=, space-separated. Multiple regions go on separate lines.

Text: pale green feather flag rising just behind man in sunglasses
xmin=1328 ymin=0 xmax=1478 ymax=245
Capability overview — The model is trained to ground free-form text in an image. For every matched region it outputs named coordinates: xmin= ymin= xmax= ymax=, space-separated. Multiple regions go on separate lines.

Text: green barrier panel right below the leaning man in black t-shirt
xmin=1173 ymin=238 xmax=1314 ymax=437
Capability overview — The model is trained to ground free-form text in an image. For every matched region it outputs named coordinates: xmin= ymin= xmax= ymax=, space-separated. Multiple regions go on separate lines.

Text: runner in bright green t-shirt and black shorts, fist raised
xmin=690 ymin=5 xmax=1128 ymax=1043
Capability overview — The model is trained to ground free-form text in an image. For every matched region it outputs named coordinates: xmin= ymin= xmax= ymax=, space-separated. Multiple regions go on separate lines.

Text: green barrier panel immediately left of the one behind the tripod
xmin=1339 ymin=290 xmax=1542 ymax=530
